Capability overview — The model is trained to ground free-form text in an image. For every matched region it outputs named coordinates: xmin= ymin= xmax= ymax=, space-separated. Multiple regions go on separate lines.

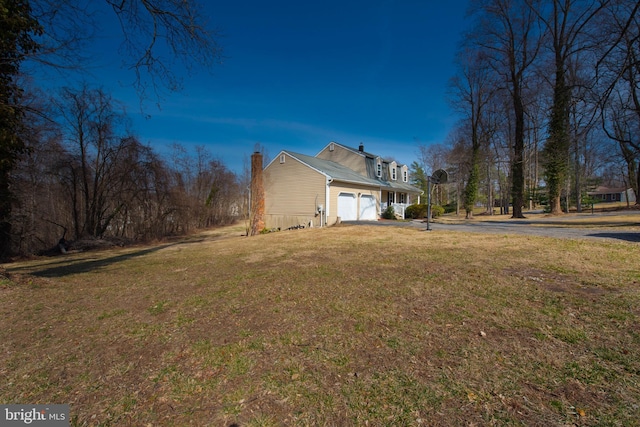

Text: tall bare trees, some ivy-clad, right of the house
xmin=413 ymin=0 xmax=640 ymax=217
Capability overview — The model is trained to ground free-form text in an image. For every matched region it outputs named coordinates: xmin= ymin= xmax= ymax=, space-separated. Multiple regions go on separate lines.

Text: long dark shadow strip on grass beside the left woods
xmin=9 ymin=239 xmax=201 ymax=278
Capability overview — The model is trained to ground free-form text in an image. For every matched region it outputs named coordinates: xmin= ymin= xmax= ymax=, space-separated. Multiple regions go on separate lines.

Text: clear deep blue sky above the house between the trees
xmin=41 ymin=0 xmax=467 ymax=173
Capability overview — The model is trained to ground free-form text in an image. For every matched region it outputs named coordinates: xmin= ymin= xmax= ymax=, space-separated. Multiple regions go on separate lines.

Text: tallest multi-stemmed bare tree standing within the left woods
xmin=58 ymin=86 xmax=140 ymax=237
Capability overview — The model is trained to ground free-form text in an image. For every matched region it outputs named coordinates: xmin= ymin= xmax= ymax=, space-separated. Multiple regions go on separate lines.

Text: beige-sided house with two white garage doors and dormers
xmin=263 ymin=142 xmax=421 ymax=229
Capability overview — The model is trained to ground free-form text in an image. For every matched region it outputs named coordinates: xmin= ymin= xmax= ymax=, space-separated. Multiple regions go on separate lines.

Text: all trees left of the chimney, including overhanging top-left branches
xmin=0 ymin=0 xmax=232 ymax=258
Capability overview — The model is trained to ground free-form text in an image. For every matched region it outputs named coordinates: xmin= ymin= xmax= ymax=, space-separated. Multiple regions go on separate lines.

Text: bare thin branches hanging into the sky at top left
xmin=25 ymin=0 xmax=222 ymax=99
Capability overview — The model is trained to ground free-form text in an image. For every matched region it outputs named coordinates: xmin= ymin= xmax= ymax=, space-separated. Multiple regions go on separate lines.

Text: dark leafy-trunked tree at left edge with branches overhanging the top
xmin=0 ymin=0 xmax=222 ymax=256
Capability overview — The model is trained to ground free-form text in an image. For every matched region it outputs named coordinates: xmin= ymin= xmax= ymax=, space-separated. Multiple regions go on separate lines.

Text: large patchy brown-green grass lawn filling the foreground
xmin=0 ymin=225 xmax=640 ymax=426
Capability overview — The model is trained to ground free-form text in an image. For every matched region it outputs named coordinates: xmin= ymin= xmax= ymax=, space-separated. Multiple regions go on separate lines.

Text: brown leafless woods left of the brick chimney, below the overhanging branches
xmin=11 ymin=87 xmax=246 ymax=254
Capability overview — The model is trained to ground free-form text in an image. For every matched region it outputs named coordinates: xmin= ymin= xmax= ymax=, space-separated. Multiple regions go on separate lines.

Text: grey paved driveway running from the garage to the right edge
xmin=347 ymin=211 xmax=640 ymax=243
